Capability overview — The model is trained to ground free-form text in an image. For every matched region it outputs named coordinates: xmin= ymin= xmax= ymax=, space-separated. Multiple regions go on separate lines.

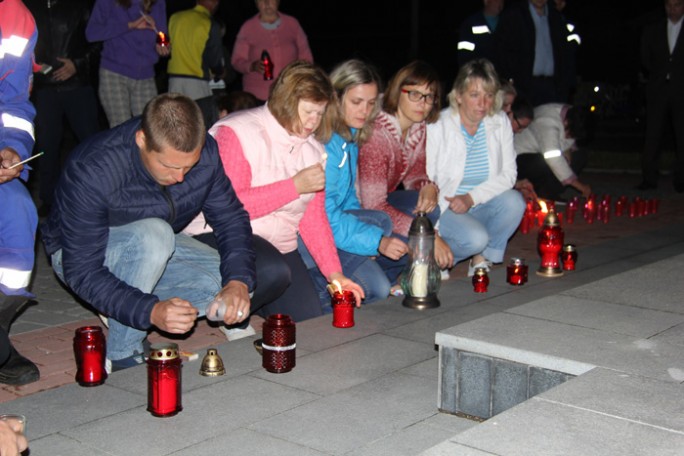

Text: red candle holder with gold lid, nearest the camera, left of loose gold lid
xmin=147 ymin=343 xmax=183 ymax=417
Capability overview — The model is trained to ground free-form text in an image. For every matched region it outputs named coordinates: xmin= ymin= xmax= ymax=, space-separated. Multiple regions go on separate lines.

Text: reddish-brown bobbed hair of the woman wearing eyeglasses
xmin=382 ymin=60 xmax=442 ymax=123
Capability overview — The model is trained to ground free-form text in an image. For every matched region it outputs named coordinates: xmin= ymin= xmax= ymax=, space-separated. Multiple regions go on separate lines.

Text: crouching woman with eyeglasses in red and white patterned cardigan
xmin=359 ymin=61 xmax=453 ymax=269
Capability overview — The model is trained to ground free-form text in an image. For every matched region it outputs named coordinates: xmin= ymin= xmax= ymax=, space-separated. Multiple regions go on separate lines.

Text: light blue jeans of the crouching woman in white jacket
xmin=439 ymin=190 xmax=525 ymax=263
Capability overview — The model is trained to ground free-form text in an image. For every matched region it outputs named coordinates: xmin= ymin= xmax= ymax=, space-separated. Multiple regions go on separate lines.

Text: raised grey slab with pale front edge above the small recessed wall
xmin=436 ymin=312 xmax=684 ymax=382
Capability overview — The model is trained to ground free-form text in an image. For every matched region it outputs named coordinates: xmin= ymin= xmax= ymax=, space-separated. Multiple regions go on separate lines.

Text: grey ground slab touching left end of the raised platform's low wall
xmin=250 ymin=373 xmax=436 ymax=454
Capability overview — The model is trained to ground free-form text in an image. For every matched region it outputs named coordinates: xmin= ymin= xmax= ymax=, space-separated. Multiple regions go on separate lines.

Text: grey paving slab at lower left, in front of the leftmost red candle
xmin=2 ymin=384 xmax=146 ymax=439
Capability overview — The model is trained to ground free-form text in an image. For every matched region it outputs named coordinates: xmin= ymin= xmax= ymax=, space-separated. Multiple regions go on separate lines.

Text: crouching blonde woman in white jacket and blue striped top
xmin=426 ymin=59 xmax=525 ymax=276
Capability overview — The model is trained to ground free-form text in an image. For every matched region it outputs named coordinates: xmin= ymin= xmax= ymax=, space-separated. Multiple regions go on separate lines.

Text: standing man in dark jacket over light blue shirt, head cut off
xmin=495 ymin=0 xmax=575 ymax=106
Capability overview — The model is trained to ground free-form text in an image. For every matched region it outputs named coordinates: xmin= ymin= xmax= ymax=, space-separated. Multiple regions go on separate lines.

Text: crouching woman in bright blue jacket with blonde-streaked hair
xmin=299 ymin=60 xmax=408 ymax=311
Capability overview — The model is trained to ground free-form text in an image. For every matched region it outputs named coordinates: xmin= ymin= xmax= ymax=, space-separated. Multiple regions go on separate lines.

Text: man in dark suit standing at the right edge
xmin=637 ymin=0 xmax=684 ymax=193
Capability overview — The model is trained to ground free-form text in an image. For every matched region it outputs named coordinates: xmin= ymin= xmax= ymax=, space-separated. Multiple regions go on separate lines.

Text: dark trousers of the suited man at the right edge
xmin=641 ymin=83 xmax=684 ymax=186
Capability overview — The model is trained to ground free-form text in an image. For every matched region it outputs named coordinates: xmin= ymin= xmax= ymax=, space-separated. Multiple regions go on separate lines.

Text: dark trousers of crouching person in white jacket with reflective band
xmin=516 ymin=149 xmax=589 ymax=201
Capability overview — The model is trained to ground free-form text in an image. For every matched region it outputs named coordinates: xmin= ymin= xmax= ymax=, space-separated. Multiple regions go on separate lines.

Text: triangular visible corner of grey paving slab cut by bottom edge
xmin=171 ymin=429 xmax=329 ymax=456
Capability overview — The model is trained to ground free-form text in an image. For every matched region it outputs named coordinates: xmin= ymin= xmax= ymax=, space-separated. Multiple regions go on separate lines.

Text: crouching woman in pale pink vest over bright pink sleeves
xmin=193 ymin=61 xmax=364 ymax=321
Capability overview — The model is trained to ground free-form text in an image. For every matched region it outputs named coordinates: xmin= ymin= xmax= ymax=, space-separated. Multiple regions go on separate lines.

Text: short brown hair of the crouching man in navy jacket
xmin=141 ymin=93 xmax=206 ymax=152
